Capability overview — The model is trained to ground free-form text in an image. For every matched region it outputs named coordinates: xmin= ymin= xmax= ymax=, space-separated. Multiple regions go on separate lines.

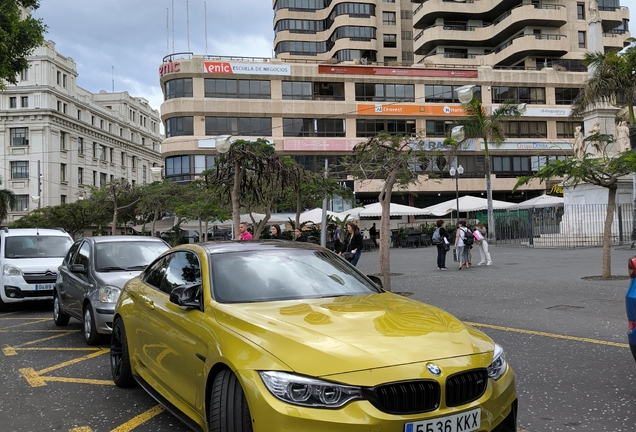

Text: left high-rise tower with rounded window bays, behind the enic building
xmin=272 ymin=0 xmax=413 ymax=65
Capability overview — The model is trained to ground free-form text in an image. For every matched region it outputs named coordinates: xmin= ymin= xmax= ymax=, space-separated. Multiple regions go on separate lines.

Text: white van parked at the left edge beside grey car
xmin=0 ymin=227 xmax=73 ymax=311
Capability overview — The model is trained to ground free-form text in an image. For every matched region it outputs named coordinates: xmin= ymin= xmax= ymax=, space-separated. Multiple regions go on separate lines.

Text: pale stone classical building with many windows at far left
xmin=0 ymin=41 xmax=162 ymax=222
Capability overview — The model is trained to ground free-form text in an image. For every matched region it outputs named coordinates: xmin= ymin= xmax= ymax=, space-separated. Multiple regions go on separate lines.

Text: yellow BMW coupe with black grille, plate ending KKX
xmin=110 ymin=240 xmax=517 ymax=432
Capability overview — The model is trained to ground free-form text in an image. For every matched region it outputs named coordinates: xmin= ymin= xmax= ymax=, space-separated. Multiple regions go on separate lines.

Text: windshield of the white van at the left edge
xmin=4 ymin=235 xmax=73 ymax=259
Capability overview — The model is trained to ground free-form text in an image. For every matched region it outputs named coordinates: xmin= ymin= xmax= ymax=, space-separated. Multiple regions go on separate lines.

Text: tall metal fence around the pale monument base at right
xmin=492 ymin=204 xmax=632 ymax=249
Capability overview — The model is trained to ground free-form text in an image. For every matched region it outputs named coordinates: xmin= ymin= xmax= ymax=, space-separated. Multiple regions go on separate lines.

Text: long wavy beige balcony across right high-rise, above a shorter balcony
xmin=413 ymin=4 xmax=567 ymax=55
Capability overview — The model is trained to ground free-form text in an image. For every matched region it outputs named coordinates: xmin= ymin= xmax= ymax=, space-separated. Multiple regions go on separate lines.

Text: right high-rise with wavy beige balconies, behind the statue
xmin=413 ymin=0 xmax=630 ymax=70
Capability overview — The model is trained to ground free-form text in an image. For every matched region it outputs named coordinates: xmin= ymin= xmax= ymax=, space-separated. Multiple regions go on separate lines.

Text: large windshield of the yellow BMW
xmin=210 ymin=249 xmax=381 ymax=303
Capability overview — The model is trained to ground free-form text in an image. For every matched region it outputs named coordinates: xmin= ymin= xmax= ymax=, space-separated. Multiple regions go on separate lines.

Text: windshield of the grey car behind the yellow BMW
xmin=95 ymin=241 xmax=169 ymax=272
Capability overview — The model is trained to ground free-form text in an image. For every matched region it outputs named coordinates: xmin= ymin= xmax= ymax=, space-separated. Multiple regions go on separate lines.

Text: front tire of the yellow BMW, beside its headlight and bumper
xmin=209 ymin=370 xmax=252 ymax=432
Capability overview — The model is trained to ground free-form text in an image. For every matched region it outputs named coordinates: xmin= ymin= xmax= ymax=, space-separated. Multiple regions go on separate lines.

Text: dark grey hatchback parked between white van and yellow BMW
xmin=53 ymin=236 xmax=170 ymax=345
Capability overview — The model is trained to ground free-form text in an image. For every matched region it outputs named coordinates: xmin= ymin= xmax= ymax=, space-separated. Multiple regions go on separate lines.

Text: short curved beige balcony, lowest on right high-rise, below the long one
xmin=486 ymin=34 xmax=570 ymax=66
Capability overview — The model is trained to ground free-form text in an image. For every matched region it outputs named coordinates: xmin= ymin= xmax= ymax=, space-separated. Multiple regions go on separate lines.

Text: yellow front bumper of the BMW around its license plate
xmin=237 ymin=367 xmax=517 ymax=432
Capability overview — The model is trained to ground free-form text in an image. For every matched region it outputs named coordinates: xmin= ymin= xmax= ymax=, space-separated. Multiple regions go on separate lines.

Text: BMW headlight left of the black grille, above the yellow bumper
xmin=259 ymin=371 xmax=362 ymax=408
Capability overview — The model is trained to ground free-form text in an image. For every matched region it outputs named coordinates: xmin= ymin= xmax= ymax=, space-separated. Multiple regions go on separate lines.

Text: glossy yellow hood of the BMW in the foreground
xmin=216 ymin=293 xmax=494 ymax=376
